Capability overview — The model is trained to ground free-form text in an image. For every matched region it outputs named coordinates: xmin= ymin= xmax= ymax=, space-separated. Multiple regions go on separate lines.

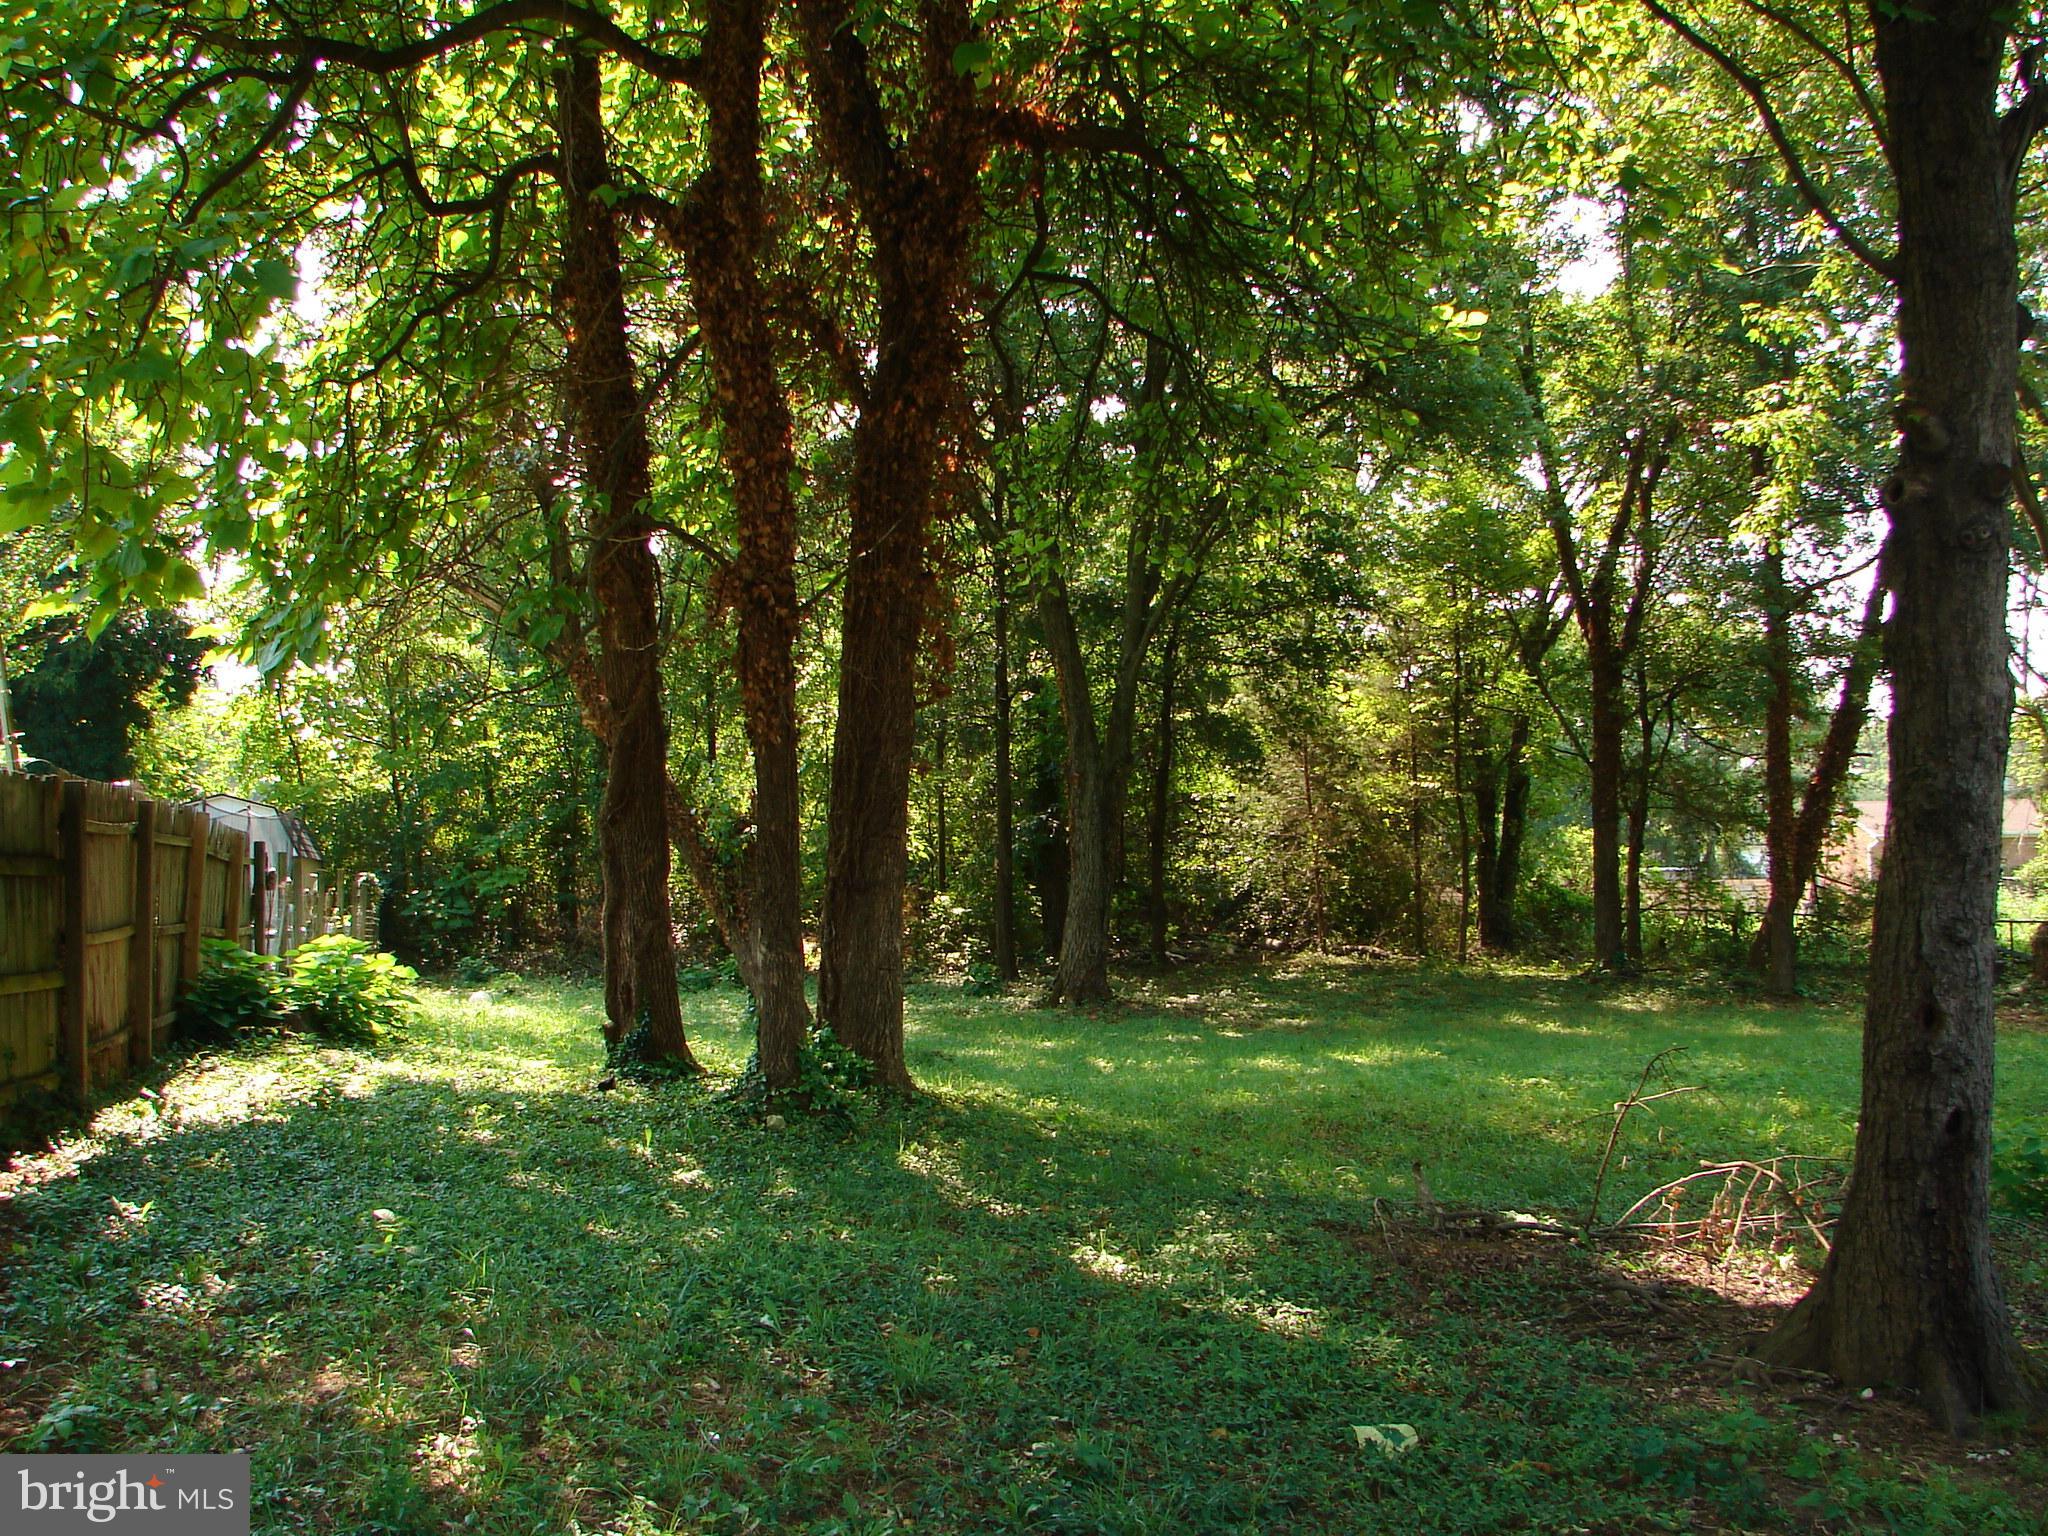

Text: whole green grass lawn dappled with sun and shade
xmin=0 ymin=963 xmax=2048 ymax=1536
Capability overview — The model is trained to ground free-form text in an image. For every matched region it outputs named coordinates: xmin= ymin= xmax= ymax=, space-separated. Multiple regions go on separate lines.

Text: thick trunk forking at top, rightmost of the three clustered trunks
xmin=797 ymin=0 xmax=989 ymax=1087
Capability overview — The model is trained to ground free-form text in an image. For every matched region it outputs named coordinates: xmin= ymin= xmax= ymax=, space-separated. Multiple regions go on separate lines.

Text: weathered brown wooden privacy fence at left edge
xmin=0 ymin=774 xmax=260 ymax=1108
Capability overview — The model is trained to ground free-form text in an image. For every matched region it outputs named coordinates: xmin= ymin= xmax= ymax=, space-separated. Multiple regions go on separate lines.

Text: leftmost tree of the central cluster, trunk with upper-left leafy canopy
xmin=6 ymin=0 xmax=737 ymax=1065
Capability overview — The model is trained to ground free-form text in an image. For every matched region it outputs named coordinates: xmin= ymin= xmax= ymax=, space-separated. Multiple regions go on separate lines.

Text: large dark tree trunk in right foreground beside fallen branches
xmin=1767 ymin=0 xmax=2040 ymax=1430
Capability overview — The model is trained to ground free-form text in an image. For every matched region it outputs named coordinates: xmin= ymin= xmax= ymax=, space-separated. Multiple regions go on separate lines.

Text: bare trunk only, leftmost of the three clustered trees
xmin=557 ymin=51 xmax=696 ymax=1071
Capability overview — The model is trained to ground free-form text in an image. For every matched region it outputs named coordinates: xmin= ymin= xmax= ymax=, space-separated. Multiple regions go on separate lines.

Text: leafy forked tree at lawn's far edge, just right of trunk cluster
xmin=985 ymin=0 xmax=1473 ymax=1004
